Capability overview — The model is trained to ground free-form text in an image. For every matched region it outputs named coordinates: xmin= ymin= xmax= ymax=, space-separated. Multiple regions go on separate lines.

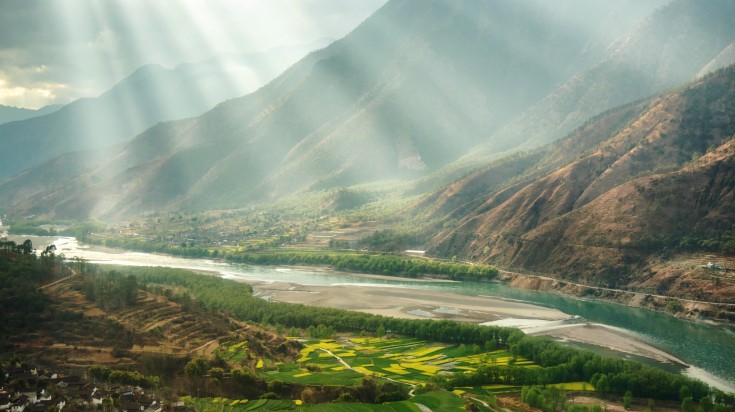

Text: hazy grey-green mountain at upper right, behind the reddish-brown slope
xmin=461 ymin=0 xmax=735 ymax=164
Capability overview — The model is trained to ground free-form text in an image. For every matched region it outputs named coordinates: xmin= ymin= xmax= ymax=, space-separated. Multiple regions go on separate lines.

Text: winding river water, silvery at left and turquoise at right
xmin=5 ymin=232 xmax=735 ymax=392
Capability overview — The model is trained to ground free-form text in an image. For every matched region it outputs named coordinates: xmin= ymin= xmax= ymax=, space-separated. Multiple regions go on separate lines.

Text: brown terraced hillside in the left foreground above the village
xmin=9 ymin=276 xmax=298 ymax=367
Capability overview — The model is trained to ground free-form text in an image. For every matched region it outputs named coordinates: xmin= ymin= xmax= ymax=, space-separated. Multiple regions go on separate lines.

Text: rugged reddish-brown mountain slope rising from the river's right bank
xmin=428 ymin=66 xmax=735 ymax=300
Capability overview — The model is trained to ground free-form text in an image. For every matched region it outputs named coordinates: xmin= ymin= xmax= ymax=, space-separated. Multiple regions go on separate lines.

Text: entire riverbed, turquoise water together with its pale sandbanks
xmin=8 ymin=233 xmax=735 ymax=394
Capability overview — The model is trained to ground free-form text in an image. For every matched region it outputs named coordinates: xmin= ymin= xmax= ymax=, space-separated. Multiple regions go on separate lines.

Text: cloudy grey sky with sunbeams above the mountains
xmin=0 ymin=0 xmax=387 ymax=109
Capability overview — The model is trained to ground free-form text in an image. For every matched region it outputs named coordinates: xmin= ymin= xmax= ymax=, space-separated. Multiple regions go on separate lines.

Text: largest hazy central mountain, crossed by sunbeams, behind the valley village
xmin=0 ymin=0 xmax=655 ymax=218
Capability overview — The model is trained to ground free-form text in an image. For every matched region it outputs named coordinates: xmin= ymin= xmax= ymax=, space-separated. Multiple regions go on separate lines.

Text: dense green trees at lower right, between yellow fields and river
xmin=448 ymin=336 xmax=735 ymax=407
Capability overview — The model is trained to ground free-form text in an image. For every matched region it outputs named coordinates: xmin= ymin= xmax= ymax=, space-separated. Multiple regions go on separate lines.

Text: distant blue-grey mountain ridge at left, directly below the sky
xmin=0 ymin=39 xmax=327 ymax=179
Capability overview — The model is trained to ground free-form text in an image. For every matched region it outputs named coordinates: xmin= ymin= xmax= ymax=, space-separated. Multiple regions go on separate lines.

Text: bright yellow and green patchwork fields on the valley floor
xmin=210 ymin=337 xmax=538 ymax=412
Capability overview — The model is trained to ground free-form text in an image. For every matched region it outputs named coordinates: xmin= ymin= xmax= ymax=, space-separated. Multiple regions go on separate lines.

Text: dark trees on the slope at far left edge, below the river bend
xmin=0 ymin=239 xmax=68 ymax=334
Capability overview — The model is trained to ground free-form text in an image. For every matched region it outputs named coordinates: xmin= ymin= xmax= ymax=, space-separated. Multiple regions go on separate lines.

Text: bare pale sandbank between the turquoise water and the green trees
xmin=249 ymin=282 xmax=687 ymax=367
